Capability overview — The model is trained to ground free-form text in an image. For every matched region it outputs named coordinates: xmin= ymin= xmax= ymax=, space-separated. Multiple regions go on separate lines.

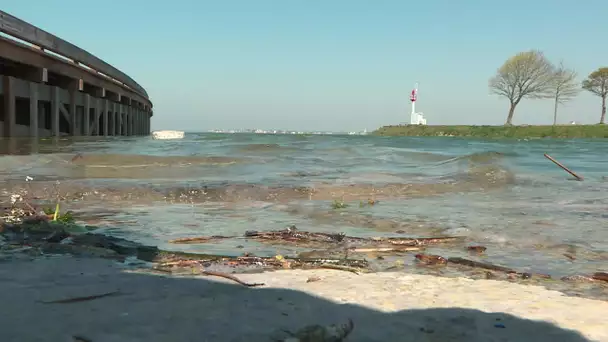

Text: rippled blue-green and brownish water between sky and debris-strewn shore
xmin=0 ymin=134 xmax=608 ymax=294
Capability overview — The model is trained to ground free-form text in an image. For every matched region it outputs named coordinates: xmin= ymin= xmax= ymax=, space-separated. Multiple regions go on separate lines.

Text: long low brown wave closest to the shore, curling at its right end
xmin=4 ymin=166 xmax=513 ymax=204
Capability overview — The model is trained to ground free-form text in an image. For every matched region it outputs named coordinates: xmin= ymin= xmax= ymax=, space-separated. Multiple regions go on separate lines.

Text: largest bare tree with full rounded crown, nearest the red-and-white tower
xmin=488 ymin=50 xmax=554 ymax=125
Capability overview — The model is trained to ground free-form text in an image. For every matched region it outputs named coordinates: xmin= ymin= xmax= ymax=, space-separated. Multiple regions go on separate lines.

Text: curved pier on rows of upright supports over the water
xmin=0 ymin=11 xmax=153 ymax=138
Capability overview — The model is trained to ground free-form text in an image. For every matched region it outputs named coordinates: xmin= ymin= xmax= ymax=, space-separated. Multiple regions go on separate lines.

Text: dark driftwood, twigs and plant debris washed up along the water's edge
xmin=0 ymin=207 xmax=608 ymax=292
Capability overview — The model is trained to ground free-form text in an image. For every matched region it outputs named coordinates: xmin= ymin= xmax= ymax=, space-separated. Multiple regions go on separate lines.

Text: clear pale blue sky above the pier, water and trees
xmin=2 ymin=0 xmax=608 ymax=131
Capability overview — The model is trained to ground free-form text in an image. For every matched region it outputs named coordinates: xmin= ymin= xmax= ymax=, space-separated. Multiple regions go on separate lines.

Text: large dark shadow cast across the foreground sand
xmin=0 ymin=257 xmax=588 ymax=342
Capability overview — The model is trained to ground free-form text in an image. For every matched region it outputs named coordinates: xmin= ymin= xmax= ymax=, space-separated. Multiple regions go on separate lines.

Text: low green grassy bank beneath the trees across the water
xmin=372 ymin=125 xmax=608 ymax=138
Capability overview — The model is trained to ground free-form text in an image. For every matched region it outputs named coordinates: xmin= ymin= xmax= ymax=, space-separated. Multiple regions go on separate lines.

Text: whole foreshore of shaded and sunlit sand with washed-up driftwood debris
xmin=0 ymin=214 xmax=608 ymax=342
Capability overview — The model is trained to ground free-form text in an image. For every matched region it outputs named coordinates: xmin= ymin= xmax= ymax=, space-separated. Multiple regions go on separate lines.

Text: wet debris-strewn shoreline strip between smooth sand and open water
xmin=0 ymin=215 xmax=608 ymax=300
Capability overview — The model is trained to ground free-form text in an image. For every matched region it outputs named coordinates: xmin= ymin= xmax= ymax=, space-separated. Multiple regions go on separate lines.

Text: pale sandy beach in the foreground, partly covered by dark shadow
xmin=0 ymin=256 xmax=608 ymax=342
